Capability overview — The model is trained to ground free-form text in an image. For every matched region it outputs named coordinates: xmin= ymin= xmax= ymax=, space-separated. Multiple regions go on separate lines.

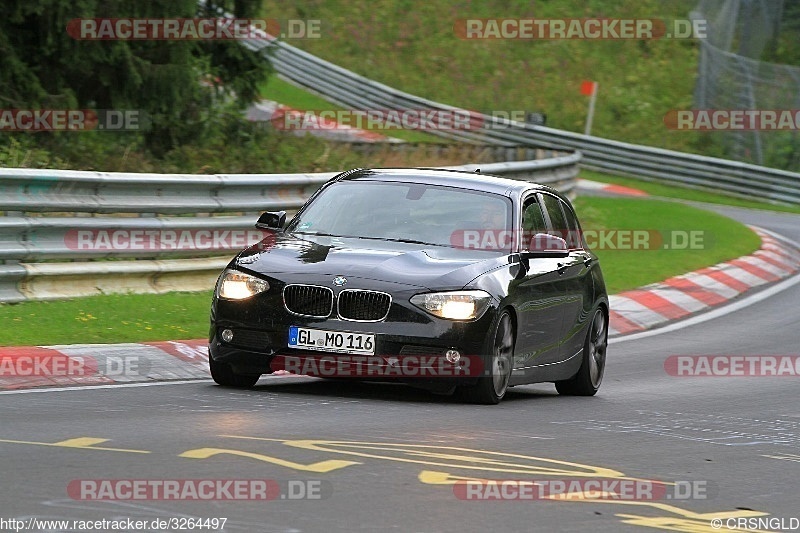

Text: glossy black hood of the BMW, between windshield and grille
xmin=232 ymin=233 xmax=508 ymax=290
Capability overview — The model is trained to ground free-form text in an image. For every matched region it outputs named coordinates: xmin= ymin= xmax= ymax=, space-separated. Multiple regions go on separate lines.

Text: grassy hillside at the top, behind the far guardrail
xmin=262 ymin=0 xmax=708 ymax=155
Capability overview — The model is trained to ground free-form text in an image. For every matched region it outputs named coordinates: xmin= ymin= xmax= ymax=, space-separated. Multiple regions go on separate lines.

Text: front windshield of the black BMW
xmin=287 ymin=181 xmax=511 ymax=247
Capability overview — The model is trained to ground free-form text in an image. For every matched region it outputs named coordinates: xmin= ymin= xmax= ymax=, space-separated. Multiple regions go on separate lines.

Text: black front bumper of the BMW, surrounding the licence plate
xmin=209 ymin=290 xmax=496 ymax=383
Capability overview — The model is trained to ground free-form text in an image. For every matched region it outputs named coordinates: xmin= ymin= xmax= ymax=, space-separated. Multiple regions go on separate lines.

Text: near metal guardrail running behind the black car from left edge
xmin=0 ymin=152 xmax=581 ymax=302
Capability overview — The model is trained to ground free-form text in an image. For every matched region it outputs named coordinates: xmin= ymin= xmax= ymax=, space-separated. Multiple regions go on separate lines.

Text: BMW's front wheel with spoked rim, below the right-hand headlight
xmin=459 ymin=311 xmax=515 ymax=405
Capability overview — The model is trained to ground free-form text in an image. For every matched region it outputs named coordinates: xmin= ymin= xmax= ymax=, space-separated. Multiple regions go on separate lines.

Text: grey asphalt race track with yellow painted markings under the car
xmin=0 ymin=208 xmax=800 ymax=533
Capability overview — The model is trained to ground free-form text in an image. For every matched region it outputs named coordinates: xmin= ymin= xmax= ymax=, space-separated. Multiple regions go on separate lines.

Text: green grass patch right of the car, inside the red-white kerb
xmin=575 ymin=197 xmax=760 ymax=294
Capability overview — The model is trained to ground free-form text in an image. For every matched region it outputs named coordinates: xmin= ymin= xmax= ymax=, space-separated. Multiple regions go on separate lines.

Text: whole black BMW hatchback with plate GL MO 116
xmin=209 ymin=169 xmax=609 ymax=404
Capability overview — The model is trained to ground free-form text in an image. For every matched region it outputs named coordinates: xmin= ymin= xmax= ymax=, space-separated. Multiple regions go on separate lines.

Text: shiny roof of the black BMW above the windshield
xmin=333 ymin=168 xmax=563 ymax=197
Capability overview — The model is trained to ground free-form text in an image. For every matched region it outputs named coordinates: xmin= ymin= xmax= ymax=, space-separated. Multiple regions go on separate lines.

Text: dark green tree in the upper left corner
xmin=0 ymin=0 xmax=271 ymax=154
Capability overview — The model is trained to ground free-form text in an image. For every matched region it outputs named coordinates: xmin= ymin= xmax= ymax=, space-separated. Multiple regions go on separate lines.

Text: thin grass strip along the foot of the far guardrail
xmin=580 ymin=169 xmax=800 ymax=214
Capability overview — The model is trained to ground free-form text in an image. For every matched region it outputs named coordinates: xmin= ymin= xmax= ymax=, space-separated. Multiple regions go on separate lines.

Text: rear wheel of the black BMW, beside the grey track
xmin=556 ymin=309 xmax=608 ymax=396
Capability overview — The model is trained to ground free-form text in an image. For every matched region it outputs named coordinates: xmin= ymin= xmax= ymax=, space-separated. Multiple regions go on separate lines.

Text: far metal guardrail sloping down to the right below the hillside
xmin=238 ymin=30 xmax=800 ymax=204
